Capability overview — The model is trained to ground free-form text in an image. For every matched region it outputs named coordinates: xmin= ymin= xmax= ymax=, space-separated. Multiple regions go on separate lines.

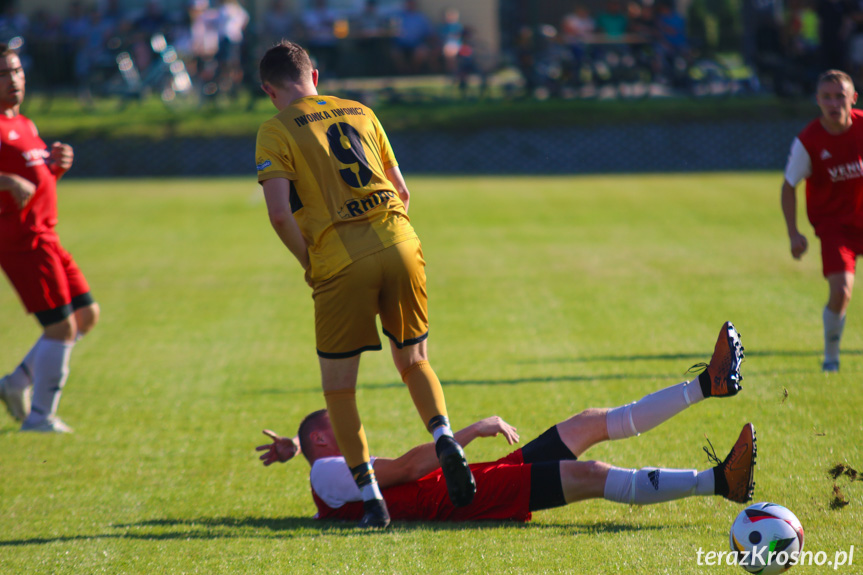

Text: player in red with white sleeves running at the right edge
xmin=782 ymin=70 xmax=863 ymax=372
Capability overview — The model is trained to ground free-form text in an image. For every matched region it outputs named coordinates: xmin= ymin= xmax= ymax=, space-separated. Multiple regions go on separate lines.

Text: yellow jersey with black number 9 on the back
xmin=255 ymin=95 xmax=416 ymax=282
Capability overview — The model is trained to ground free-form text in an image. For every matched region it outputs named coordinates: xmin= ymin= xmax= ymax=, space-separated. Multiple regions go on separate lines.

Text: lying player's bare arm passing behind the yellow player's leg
xmin=375 ymin=416 xmax=519 ymax=488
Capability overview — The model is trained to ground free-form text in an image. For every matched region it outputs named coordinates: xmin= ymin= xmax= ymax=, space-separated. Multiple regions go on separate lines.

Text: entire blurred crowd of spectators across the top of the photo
xmin=5 ymin=0 xmax=863 ymax=103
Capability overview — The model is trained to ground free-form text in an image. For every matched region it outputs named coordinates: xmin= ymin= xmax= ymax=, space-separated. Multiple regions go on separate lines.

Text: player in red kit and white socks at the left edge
xmin=0 ymin=44 xmax=99 ymax=433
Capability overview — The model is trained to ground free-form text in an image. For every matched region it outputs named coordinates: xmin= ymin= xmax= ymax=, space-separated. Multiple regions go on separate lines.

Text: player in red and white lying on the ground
xmin=257 ymin=322 xmax=756 ymax=521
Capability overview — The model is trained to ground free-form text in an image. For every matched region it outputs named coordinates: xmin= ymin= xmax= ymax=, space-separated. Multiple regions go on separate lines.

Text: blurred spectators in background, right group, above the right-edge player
xmin=502 ymin=0 xmax=863 ymax=95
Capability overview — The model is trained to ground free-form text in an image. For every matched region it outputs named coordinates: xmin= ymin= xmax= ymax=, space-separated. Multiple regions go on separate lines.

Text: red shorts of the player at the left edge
xmin=0 ymin=240 xmax=90 ymax=325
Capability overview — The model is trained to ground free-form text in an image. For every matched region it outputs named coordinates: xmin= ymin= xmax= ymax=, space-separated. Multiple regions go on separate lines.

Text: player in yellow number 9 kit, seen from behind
xmin=256 ymin=40 xmax=476 ymax=528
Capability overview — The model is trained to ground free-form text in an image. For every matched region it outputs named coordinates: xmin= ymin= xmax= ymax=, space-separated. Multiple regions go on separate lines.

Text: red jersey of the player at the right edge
xmin=792 ymin=110 xmax=863 ymax=236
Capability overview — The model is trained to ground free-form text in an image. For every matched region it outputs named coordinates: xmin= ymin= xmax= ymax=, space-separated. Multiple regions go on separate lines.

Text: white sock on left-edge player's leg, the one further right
xmin=27 ymin=338 xmax=75 ymax=423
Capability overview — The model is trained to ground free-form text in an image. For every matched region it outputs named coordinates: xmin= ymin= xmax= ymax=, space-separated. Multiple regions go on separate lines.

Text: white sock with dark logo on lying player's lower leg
xmin=603 ymin=467 xmax=714 ymax=505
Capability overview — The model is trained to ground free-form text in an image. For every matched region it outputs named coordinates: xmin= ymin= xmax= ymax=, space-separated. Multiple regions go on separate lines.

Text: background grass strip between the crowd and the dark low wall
xmin=18 ymin=93 xmax=817 ymax=140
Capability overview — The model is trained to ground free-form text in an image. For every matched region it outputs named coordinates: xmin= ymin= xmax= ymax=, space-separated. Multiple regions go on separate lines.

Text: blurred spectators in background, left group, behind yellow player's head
xmin=0 ymin=0 xmax=480 ymax=102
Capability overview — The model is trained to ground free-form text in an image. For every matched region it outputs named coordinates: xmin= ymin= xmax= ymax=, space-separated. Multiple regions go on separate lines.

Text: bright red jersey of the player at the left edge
xmin=0 ymin=114 xmax=57 ymax=252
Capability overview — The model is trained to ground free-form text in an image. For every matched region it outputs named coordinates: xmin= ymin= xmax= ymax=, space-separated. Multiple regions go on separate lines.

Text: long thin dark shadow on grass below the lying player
xmin=0 ymin=517 xmax=666 ymax=547
